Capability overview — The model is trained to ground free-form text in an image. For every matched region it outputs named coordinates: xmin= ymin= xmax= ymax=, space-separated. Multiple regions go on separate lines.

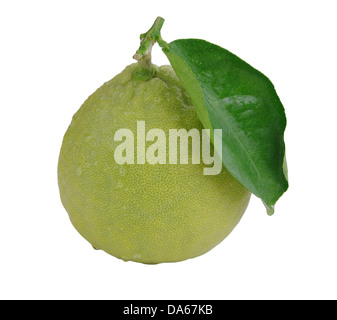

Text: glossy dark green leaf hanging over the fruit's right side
xmin=163 ymin=39 xmax=288 ymax=214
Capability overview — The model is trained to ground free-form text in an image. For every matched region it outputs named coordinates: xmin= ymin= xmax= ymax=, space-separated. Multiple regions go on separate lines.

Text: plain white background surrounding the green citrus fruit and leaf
xmin=0 ymin=0 xmax=337 ymax=299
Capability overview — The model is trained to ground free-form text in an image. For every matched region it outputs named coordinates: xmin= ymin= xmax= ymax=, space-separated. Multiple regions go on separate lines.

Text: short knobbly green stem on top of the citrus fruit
xmin=133 ymin=17 xmax=167 ymax=80
